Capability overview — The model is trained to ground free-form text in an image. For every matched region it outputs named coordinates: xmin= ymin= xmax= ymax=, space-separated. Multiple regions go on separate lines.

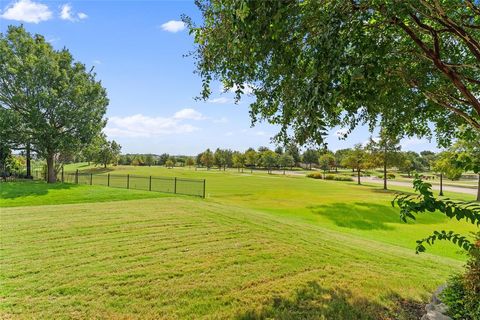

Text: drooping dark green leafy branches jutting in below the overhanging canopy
xmin=392 ymin=175 xmax=480 ymax=253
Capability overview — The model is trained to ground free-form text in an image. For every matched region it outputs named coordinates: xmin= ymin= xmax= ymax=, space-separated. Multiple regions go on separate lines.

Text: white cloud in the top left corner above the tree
xmin=0 ymin=0 xmax=53 ymax=23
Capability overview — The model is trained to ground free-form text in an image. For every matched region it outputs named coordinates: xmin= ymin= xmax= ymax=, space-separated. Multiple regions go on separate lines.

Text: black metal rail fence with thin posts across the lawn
xmin=32 ymin=170 xmax=206 ymax=198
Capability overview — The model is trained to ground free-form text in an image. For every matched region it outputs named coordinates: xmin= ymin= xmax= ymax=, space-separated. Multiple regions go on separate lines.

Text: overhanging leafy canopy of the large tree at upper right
xmin=184 ymin=0 xmax=480 ymax=145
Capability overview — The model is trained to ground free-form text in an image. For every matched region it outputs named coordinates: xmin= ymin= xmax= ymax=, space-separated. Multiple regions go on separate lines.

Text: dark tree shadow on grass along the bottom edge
xmin=236 ymin=281 xmax=423 ymax=320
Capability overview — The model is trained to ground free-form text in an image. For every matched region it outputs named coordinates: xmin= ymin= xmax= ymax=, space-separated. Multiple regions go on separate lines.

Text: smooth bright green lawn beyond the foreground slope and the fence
xmin=67 ymin=164 xmax=475 ymax=259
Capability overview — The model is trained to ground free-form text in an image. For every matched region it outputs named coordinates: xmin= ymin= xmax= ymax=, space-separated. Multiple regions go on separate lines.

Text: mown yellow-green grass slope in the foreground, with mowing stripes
xmin=0 ymin=198 xmax=460 ymax=319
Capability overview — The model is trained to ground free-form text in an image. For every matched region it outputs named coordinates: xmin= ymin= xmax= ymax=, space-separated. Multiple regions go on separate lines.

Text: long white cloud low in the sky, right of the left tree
xmin=104 ymin=114 xmax=198 ymax=137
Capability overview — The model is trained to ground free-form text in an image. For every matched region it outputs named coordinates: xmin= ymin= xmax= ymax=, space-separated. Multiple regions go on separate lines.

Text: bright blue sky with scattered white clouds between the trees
xmin=0 ymin=0 xmax=436 ymax=155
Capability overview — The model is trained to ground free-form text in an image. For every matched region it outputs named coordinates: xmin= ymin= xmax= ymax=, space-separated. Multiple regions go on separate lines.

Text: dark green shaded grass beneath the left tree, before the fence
xmin=0 ymin=181 xmax=77 ymax=199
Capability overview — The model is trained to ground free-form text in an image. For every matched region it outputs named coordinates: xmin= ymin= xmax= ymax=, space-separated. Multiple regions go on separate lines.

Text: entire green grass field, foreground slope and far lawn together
xmin=0 ymin=165 xmax=478 ymax=319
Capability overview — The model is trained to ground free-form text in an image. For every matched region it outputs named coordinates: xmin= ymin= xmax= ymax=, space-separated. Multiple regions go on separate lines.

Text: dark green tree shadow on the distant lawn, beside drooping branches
xmin=308 ymin=202 xmax=444 ymax=230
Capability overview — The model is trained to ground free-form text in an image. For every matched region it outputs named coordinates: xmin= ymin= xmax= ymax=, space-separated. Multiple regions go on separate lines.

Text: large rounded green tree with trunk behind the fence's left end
xmin=0 ymin=26 xmax=108 ymax=183
